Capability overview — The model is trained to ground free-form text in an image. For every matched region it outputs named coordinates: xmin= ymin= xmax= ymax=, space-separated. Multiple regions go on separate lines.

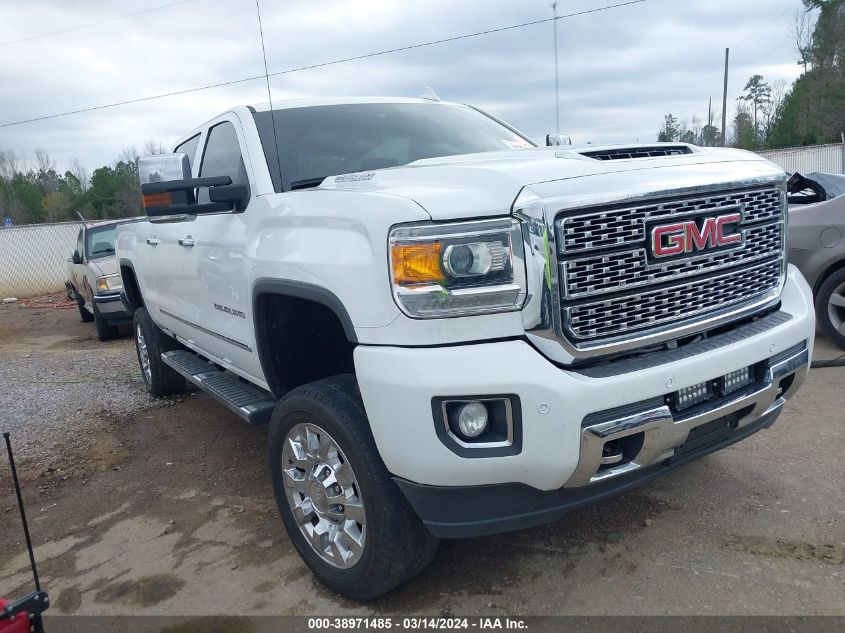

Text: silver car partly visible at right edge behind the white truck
xmin=788 ymin=174 xmax=845 ymax=349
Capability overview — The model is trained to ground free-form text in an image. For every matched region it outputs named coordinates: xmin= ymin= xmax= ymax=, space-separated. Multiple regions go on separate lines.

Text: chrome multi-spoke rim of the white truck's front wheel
xmin=281 ymin=423 xmax=367 ymax=569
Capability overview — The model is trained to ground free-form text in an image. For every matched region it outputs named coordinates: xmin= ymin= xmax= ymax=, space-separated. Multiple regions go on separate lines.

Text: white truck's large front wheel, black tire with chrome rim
xmin=268 ymin=375 xmax=438 ymax=600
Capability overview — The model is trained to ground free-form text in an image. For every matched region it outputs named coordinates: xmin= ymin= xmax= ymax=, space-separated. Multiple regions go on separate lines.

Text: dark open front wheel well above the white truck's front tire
xmin=252 ymin=279 xmax=358 ymax=398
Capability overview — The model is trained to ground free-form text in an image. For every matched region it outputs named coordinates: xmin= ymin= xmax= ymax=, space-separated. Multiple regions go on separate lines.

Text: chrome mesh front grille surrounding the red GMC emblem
xmin=555 ymin=187 xmax=784 ymax=344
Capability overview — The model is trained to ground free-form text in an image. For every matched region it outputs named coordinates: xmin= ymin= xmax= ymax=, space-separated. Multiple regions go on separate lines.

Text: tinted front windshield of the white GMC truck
xmin=254 ymin=103 xmax=533 ymax=191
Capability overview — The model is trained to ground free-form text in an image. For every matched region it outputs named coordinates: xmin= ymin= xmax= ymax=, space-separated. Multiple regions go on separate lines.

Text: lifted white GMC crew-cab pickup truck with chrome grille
xmin=117 ymin=98 xmax=814 ymax=600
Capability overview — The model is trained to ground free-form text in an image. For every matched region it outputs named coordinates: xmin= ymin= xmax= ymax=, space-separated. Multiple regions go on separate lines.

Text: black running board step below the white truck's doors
xmin=161 ymin=350 xmax=276 ymax=424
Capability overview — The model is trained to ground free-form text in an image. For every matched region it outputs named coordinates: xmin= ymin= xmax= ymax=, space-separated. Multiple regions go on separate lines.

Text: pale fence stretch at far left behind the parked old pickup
xmin=0 ymin=222 xmax=82 ymax=299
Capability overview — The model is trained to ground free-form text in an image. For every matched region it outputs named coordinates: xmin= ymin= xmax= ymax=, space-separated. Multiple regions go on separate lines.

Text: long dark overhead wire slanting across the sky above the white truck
xmin=0 ymin=0 xmax=648 ymax=128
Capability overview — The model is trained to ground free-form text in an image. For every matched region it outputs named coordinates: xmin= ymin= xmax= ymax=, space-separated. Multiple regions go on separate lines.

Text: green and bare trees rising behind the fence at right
xmin=657 ymin=0 xmax=845 ymax=150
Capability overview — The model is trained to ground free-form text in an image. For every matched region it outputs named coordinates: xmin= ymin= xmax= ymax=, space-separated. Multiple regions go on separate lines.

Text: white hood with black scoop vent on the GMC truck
xmin=319 ymin=143 xmax=773 ymax=220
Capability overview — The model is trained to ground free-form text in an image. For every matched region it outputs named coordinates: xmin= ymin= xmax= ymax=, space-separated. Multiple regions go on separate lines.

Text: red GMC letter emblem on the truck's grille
xmin=651 ymin=213 xmax=742 ymax=257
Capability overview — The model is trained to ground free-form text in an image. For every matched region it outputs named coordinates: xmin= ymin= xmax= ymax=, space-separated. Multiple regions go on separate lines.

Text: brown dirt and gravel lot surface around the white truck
xmin=0 ymin=298 xmax=845 ymax=615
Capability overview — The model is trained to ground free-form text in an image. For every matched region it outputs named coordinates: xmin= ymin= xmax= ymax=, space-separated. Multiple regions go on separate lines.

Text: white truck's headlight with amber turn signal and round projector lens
xmin=390 ymin=218 xmax=525 ymax=318
